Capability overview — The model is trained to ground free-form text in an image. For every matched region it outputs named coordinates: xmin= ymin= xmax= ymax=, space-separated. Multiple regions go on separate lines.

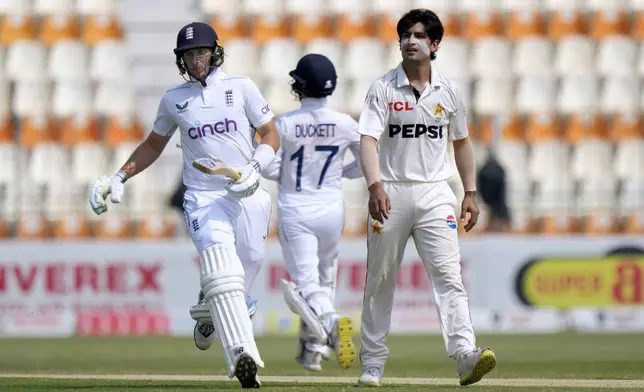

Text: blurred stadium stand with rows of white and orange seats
xmin=0 ymin=0 xmax=644 ymax=239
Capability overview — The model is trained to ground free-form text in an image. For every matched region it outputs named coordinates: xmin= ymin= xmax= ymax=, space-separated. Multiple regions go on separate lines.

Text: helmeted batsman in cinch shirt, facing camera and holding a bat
xmin=90 ymin=22 xmax=279 ymax=388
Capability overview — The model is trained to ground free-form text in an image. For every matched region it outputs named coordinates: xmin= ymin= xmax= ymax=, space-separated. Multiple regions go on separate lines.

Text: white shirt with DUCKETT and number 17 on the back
xmin=268 ymin=98 xmax=360 ymax=219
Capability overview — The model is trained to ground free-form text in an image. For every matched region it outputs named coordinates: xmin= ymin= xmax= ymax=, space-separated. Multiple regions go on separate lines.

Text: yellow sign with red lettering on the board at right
xmin=517 ymin=256 xmax=644 ymax=308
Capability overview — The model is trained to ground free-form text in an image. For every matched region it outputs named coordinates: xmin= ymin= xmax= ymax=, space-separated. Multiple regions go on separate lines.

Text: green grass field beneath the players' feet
xmin=0 ymin=334 xmax=644 ymax=392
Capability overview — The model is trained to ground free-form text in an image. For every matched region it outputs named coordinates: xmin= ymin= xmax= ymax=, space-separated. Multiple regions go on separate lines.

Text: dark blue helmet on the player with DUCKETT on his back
xmin=289 ymin=53 xmax=338 ymax=98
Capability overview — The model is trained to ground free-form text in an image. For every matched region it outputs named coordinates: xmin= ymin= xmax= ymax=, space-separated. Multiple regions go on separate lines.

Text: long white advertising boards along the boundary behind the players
xmin=0 ymin=236 xmax=644 ymax=336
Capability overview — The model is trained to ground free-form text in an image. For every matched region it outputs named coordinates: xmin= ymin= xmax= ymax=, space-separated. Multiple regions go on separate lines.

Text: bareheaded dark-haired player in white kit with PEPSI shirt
xmin=358 ymin=9 xmax=496 ymax=386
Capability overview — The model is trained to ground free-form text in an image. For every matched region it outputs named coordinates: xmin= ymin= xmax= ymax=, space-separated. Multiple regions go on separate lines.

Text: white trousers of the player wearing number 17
xmin=277 ymin=202 xmax=344 ymax=316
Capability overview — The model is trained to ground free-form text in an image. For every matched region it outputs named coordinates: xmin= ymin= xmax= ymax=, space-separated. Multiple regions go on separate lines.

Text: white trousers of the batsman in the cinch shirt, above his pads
xmin=184 ymin=188 xmax=272 ymax=294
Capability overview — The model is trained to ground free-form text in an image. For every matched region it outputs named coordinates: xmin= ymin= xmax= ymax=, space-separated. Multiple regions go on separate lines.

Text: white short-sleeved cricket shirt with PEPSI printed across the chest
xmin=358 ymin=63 xmax=468 ymax=182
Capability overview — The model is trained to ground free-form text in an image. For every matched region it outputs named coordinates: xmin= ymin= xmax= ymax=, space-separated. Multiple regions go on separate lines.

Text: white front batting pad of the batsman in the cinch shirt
xmin=201 ymin=244 xmax=264 ymax=378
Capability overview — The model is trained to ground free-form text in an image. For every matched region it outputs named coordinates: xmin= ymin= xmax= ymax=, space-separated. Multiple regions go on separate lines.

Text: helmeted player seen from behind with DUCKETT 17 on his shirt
xmin=263 ymin=54 xmax=362 ymax=371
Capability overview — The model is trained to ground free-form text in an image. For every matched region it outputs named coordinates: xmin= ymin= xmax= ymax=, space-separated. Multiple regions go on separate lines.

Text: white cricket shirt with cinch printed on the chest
xmin=154 ymin=68 xmax=273 ymax=191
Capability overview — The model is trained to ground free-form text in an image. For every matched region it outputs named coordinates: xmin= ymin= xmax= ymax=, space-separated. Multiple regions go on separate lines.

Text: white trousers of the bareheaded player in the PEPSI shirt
xmin=360 ymin=181 xmax=475 ymax=369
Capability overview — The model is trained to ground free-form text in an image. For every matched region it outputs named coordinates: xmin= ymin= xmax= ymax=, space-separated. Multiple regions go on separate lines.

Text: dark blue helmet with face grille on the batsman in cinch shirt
xmin=174 ymin=22 xmax=224 ymax=86
